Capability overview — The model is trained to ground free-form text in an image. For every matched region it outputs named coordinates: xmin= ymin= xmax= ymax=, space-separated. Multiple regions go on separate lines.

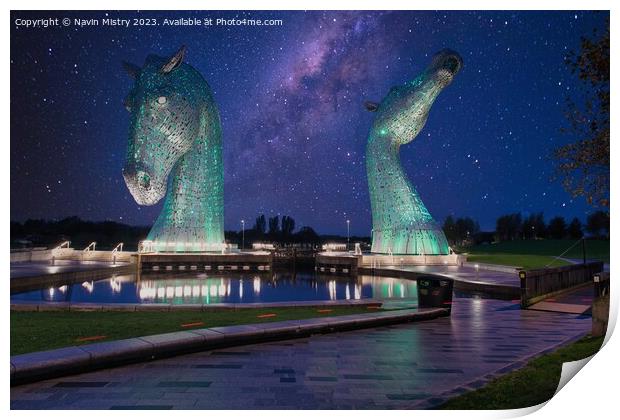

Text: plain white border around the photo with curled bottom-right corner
xmin=0 ymin=0 xmax=620 ymax=420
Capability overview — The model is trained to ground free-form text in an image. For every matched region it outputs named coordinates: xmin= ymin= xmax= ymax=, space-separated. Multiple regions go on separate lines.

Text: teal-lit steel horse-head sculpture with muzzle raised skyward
xmin=365 ymin=50 xmax=463 ymax=255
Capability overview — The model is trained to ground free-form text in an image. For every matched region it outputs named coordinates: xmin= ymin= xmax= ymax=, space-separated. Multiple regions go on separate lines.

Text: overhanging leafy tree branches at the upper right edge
xmin=553 ymin=21 xmax=610 ymax=207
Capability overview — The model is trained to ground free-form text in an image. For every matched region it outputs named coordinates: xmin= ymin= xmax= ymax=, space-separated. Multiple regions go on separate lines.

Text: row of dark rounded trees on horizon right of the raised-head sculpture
xmin=443 ymin=211 xmax=609 ymax=246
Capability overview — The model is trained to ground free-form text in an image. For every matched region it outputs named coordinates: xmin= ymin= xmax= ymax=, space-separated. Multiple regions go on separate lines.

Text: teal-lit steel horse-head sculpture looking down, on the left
xmin=123 ymin=47 xmax=224 ymax=251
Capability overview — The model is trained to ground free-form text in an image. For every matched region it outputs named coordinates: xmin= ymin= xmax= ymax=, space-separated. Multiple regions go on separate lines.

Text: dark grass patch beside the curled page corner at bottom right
xmin=438 ymin=337 xmax=603 ymax=410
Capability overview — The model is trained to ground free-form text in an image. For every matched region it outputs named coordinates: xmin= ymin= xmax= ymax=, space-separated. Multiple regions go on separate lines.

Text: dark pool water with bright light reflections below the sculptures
xmin=11 ymin=272 xmax=417 ymax=304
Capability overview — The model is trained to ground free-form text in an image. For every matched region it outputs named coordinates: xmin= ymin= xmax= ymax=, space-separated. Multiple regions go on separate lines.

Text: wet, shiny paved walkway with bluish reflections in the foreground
xmin=11 ymin=298 xmax=591 ymax=409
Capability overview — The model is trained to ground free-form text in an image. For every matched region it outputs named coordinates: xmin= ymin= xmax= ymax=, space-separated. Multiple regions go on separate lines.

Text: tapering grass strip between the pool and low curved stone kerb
xmin=11 ymin=306 xmax=383 ymax=355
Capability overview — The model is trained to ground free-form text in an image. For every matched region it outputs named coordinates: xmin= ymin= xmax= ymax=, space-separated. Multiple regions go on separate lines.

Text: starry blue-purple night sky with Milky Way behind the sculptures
xmin=10 ymin=11 xmax=609 ymax=235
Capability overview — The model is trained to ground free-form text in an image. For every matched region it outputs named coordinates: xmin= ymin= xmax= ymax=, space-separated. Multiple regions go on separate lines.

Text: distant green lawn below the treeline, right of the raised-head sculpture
xmin=463 ymin=239 xmax=609 ymax=269
